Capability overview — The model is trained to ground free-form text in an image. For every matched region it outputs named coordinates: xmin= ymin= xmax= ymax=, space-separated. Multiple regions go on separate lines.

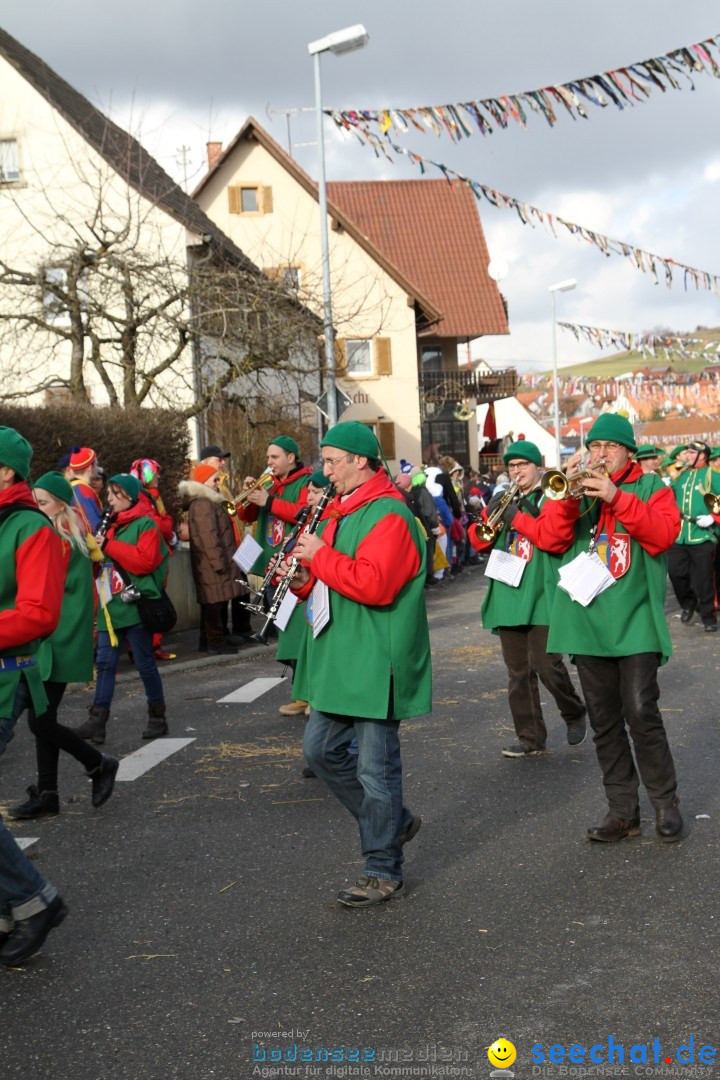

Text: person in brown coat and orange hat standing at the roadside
xmin=178 ymin=464 xmax=245 ymax=654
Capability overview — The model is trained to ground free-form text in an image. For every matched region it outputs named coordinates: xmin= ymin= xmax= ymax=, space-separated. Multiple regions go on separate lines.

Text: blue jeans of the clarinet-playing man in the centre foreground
xmin=303 ymin=708 xmax=412 ymax=881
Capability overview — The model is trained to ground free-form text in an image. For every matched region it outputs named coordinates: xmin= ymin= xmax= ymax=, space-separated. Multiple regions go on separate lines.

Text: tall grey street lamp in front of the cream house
xmin=308 ymin=24 xmax=369 ymax=428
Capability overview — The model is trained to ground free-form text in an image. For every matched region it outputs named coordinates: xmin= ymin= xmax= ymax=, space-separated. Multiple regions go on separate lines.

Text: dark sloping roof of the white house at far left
xmin=0 ymin=28 xmax=255 ymax=273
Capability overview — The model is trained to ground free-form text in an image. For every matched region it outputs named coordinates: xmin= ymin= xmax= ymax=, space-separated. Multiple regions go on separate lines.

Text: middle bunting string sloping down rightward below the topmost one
xmin=362 ymin=137 xmax=720 ymax=297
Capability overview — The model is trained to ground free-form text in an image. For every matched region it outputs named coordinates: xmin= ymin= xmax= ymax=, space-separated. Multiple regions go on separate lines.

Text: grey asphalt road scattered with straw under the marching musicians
xmin=0 ymin=570 xmax=720 ymax=1080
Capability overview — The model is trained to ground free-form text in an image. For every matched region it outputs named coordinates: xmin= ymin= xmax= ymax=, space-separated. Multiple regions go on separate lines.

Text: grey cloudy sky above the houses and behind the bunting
xmin=2 ymin=0 xmax=720 ymax=369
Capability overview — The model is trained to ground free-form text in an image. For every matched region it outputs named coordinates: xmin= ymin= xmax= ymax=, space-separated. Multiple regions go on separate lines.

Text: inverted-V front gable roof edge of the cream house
xmin=192 ymin=117 xmax=444 ymax=333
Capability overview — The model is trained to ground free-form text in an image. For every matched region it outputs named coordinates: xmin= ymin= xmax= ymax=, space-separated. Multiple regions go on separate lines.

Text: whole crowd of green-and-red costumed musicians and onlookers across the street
xmin=0 ymin=414 xmax=720 ymax=966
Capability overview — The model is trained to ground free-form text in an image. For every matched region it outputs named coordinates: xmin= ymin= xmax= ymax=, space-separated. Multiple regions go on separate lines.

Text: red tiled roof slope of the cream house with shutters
xmin=327 ymin=180 xmax=510 ymax=338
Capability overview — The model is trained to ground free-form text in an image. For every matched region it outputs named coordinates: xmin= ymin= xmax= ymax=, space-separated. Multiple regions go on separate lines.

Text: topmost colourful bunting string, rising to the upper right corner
xmin=325 ymin=35 xmax=720 ymax=143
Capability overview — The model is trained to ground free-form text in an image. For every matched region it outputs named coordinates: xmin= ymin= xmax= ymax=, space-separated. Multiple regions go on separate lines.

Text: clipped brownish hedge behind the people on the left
xmin=0 ymin=404 xmax=190 ymax=508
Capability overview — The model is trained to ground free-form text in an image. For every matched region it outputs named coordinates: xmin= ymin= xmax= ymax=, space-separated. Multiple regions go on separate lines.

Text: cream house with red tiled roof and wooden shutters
xmin=193 ymin=119 xmax=516 ymax=467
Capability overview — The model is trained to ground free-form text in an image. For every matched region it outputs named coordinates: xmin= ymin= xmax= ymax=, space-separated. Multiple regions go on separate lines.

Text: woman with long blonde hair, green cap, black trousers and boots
xmin=10 ymin=472 xmax=119 ymax=820
